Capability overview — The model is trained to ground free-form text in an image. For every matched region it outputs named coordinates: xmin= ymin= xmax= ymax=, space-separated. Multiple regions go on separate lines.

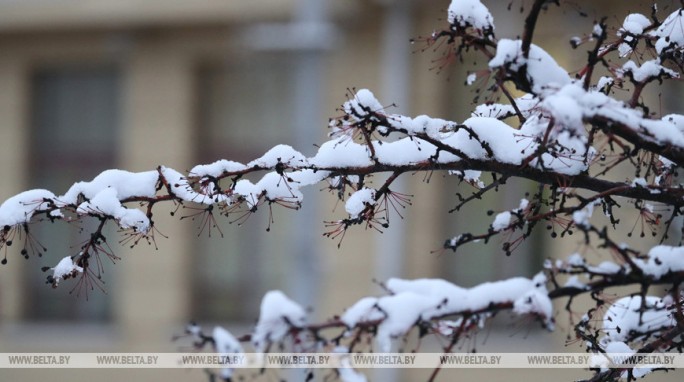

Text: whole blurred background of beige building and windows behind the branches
xmin=0 ymin=0 xmax=676 ymax=381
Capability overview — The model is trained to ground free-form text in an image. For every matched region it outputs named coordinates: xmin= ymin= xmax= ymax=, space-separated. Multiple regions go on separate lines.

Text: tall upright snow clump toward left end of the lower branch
xmin=252 ymin=290 xmax=306 ymax=353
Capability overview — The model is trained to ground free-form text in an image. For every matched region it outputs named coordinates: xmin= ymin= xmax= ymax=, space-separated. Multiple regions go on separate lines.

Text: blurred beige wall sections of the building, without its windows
xmin=0 ymin=0 xmax=672 ymax=381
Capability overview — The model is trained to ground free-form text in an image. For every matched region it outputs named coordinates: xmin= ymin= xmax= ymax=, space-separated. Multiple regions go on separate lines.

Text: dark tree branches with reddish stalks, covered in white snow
xmin=0 ymin=0 xmax=684 ymax=380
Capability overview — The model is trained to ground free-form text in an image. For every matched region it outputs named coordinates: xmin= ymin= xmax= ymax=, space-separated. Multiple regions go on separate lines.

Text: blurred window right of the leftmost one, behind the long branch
xmin=194 ymin=53 xmax=292 ymax=321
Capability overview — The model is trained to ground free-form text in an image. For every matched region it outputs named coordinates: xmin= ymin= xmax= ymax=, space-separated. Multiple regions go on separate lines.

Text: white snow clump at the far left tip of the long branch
xmin=0 ymin=189 xmax=55 ymax=227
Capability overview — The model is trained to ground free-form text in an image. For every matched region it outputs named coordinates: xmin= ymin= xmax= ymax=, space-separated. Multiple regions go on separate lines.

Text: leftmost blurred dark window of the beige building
xmin=23 ymin=67 xmax=121 ymax=322
